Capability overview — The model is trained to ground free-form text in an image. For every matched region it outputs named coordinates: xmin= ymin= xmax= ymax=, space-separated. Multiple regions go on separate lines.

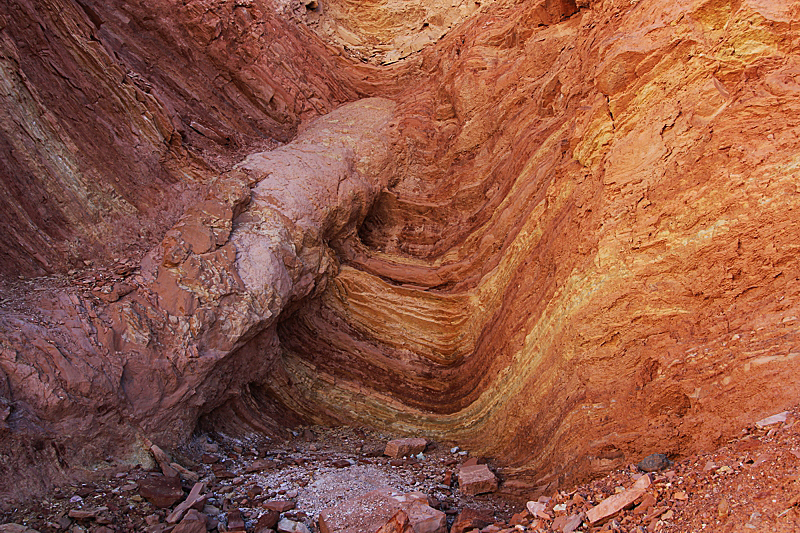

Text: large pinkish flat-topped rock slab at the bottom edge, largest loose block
xmin=319 ymin=488 xmax=447 ymax=533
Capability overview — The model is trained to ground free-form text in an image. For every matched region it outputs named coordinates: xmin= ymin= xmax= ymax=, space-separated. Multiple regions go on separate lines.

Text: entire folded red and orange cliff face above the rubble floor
xmin=0 ymin=0 xmax=800 ymax=502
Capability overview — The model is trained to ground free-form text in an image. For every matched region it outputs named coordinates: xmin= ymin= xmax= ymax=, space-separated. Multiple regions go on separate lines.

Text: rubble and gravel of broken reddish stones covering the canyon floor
xmin=0 ymin=410 xmax=800 ymax=533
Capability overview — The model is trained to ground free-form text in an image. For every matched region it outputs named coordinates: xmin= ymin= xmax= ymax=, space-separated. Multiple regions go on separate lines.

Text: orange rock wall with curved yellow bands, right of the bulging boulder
xmin=270 ymin=2 xmax=798 ymax=490
